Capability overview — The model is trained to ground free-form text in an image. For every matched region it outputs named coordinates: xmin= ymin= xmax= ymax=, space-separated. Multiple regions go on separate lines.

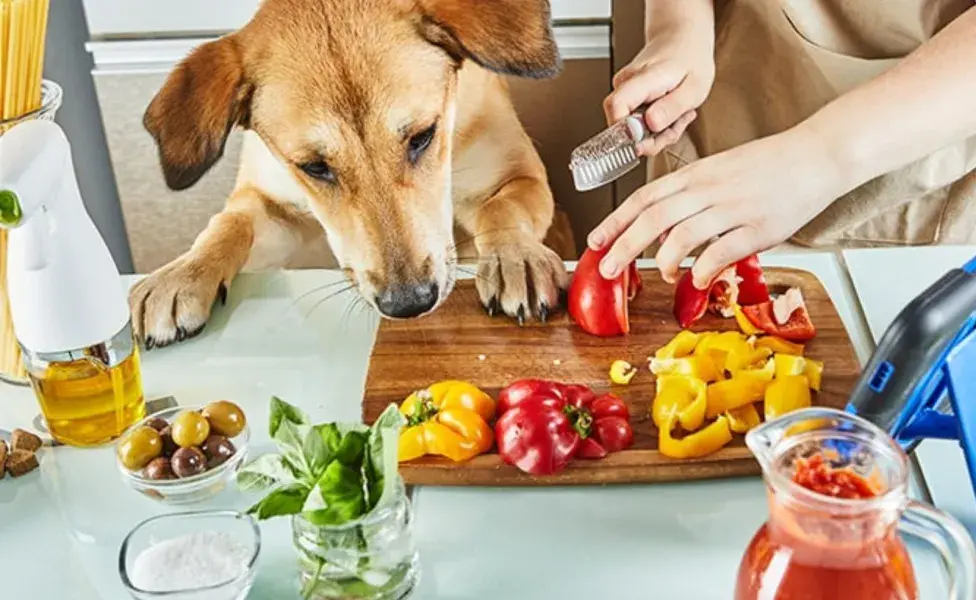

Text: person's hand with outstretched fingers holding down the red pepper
xmin=587 ymin=127 xmax=845 ymax=289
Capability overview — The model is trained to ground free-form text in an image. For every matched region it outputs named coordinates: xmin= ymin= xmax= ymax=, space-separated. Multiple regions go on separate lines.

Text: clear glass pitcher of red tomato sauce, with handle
xmin=735 ymin=408 xmax=976 ymax=600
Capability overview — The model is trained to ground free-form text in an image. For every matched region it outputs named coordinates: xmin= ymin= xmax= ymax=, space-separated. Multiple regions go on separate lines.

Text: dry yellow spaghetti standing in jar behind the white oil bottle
xmin=0 ymin=0 xmax=50 ymax=380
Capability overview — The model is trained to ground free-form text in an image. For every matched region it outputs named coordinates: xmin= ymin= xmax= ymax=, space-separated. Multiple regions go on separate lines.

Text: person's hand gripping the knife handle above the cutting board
xmin=603 ymin=0 xmax=715 ymax=156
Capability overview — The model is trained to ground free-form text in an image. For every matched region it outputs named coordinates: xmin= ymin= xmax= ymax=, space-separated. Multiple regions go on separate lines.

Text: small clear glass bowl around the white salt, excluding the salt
xmin=119 ymin=510 xmax=261 ymax=600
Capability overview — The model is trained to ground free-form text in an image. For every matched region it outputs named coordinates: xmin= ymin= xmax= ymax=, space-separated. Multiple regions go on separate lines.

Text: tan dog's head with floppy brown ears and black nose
xmin=144 ymin=0 xmax=559 ymax=318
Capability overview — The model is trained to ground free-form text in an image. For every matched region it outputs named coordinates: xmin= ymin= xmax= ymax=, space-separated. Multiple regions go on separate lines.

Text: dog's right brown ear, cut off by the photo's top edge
xmin=418 ymin=0 xmax=562 ymax=78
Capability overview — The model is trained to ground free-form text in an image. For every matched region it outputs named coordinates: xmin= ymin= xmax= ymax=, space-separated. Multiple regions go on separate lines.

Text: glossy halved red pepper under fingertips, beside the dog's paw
xmin=567 ymin=246 xmax=641 ymax=337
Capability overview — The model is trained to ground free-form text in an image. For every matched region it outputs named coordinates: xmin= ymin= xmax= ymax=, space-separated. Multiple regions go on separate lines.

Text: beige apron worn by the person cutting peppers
xmin=648 ymin=0 xmax=976 ymax=247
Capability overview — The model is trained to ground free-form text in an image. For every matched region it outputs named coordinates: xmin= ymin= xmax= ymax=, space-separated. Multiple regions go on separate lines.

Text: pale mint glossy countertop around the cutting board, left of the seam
xmin=0 ymin=254 xmax=945 ymax=600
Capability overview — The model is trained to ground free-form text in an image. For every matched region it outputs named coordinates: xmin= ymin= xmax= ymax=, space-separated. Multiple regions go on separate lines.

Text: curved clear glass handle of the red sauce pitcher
xmin=898 ymin=501 xmax=976 ymax=600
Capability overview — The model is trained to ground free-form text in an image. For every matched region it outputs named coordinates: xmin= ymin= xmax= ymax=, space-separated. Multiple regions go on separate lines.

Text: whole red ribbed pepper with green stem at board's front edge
xmin=495 ymin=379 xmax=634 ymax=475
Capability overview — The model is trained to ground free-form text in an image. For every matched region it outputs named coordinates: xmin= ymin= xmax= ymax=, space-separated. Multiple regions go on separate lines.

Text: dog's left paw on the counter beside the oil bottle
xmin=129 ymin=257 xmax=230 ymax=350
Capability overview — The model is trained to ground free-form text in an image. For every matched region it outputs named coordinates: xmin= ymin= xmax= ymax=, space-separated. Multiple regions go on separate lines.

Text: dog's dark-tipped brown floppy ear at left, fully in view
xmin=143 ymin=36 xmax=251 ymax=190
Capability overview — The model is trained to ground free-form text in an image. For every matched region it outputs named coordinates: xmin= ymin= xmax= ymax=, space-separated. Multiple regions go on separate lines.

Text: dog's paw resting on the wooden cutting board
xmin=475 ymin=242 xmax=569 ymax=325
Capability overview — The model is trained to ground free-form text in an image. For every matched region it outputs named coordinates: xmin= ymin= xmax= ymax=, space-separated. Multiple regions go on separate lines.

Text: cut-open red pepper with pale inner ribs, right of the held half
xmin=674 ymin=255 xmax=769 ymax=329
